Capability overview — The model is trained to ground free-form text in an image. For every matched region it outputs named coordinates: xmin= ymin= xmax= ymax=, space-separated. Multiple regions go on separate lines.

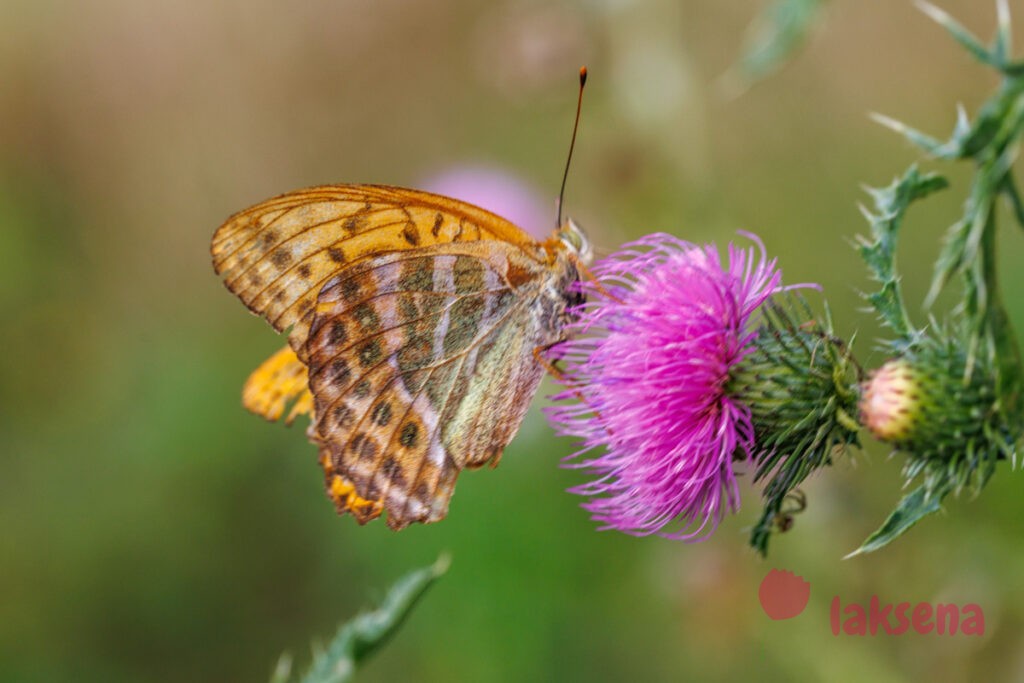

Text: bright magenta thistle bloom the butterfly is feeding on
xmin=548 ymin=234 xmax=782 ymax=540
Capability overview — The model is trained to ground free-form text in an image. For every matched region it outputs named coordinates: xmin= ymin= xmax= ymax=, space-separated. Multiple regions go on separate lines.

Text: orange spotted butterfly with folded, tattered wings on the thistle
xmin=211 ymin=184 xmax=592 ymax=529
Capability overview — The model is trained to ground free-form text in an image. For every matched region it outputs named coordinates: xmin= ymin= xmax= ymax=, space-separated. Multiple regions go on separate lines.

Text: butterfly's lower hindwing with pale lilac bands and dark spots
xmin=306 ymin=243 xmax=548 ymax=528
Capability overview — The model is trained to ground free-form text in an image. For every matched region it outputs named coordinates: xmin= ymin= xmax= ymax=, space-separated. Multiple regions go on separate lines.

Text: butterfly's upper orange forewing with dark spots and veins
xmin=211 ymin=185 xmax=534 ymax=360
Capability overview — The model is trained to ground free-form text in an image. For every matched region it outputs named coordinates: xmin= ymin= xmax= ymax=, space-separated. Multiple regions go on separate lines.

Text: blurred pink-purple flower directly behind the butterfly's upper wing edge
xmin=421 ymin=165 xmax=555 ymax=240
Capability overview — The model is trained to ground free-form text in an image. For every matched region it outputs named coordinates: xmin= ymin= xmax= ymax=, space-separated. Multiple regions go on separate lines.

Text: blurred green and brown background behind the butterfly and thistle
xmin=0 ymin=0 xmax=1024 ymax=682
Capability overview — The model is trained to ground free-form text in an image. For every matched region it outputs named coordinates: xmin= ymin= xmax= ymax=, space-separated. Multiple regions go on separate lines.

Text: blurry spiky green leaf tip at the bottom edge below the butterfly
xmin=271 ymin=555 xmax=450 ymax=683
